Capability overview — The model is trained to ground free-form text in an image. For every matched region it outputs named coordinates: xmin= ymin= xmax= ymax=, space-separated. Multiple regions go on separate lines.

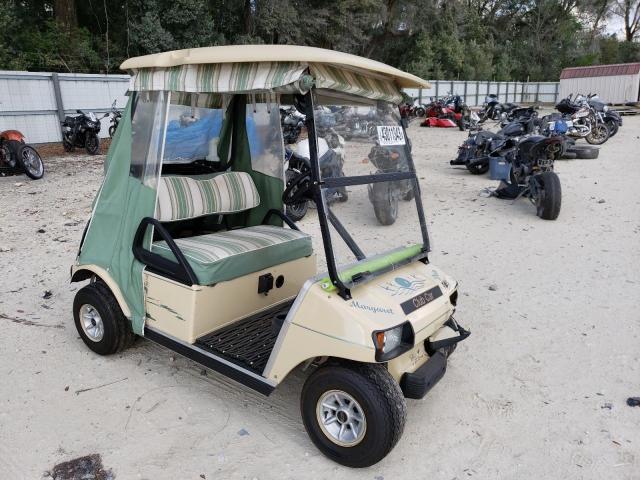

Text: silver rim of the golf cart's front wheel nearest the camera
xmin=316 ymin=390 xmax=367 ymax=447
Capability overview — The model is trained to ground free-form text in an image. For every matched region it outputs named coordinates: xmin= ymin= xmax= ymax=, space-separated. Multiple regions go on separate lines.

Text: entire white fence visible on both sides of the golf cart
xmin=0 ymin=71 xmax=558 ymax=143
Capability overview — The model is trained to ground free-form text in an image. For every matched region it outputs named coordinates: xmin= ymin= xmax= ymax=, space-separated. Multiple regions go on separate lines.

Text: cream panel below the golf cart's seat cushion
xmin=144 ymin=255 xmax=316 ymax=343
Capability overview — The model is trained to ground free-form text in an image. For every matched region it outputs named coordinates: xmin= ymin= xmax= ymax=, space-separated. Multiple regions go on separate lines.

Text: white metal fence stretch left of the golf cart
xmin=0 ymin=71 xmax=129 ymax=143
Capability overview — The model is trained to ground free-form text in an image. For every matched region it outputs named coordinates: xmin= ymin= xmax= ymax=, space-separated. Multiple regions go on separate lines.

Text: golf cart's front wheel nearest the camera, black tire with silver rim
xmin=300 ymin=363 xmax=406 ymax=468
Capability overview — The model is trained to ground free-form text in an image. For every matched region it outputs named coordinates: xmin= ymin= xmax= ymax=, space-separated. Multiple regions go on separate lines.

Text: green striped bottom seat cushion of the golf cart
xmin=152 ymin=225 xmax=313 ymax=285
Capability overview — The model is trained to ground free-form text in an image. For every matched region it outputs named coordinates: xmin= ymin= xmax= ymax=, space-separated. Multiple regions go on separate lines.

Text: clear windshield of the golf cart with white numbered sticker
xmin=295 ymin=97 xmax=428 ymax=286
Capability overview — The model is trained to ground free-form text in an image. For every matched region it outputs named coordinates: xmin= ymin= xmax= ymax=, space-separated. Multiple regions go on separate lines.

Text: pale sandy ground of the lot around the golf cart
xmin=0 ymin=117 xmax=640 ymax=480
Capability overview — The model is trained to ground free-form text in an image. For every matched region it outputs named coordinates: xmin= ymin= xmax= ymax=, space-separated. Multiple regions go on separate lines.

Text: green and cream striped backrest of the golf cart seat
xmin=156 ymin=172 xmax=260 ymax=222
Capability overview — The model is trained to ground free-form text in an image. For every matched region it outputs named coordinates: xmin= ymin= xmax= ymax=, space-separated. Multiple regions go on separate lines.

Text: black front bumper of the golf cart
xmin=400 ymin=317 xmax=471 ymax=400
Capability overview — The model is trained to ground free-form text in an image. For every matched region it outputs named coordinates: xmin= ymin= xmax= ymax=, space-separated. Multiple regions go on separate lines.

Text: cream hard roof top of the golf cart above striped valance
xmin=120 ymin=45 xmax=430 ymax=88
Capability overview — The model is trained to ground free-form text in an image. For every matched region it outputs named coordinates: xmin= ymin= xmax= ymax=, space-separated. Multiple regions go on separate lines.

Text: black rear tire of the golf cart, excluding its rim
xmin=73 ymin=281 xmax=135 ymax=355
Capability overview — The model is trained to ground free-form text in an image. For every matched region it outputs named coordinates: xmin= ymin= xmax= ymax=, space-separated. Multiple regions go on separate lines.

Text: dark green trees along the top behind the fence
xmin=0 ymin=0 xmax=640 ymax=81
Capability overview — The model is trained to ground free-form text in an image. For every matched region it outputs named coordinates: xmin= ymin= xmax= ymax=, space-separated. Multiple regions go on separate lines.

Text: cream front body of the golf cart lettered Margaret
xmin=264 ymin=262 xmax=455 ymax=382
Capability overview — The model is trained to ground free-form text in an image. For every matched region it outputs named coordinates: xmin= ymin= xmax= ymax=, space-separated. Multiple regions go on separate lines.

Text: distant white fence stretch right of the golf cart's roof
xmin=405 ymin=80 xmax=558 ymax=106
